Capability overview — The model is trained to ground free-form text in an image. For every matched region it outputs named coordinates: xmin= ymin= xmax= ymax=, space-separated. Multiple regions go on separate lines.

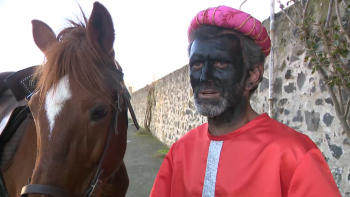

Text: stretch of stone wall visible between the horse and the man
xmin=131 ymin=66 xmax=206 ymax=147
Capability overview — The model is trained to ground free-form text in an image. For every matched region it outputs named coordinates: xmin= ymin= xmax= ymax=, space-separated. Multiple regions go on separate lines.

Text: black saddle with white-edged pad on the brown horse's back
xmin=0 ymin=66 xmax=36 ymax=196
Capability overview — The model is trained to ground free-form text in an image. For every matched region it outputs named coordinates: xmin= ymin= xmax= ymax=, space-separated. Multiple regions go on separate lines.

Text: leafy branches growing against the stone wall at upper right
xmin=277 ymin=0 xmax=350 ymax=137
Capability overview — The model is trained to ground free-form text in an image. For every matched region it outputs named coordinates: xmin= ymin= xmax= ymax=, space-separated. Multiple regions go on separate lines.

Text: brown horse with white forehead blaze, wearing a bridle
xmin=2 ymin=2 xmax=137 ymax=197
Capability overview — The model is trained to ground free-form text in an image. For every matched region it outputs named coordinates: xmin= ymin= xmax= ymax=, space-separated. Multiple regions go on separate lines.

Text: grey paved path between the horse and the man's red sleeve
xmin=124 ymin=124 xmax=167 ymax=197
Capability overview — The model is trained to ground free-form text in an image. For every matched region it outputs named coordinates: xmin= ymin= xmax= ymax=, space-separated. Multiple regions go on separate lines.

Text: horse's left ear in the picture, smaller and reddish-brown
xmin=32 ymin=20 xmax=58 ymax=53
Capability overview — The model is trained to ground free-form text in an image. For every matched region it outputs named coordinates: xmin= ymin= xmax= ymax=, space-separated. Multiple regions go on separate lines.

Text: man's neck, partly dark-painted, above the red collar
xmin=208 ymin=98 xmax=259 ymax=136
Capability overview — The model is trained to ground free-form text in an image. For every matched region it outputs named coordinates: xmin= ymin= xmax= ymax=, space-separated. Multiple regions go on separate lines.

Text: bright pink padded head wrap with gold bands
xmin=187 ymin=6 xmax=271 ymax=56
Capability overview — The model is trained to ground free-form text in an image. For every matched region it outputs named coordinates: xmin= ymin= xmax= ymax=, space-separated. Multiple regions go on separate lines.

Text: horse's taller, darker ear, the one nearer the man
xmin=87 ymin=2 xmax=114 ymax=55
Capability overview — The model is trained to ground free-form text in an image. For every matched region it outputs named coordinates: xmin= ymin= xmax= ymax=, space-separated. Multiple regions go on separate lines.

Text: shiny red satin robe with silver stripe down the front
xmin=150 ymin=114 xmax=341 ymax=197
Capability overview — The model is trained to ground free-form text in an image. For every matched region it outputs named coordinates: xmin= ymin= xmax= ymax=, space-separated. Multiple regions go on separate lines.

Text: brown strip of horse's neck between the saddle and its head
xmin=3 ymin=119 xmax=37 ymax=197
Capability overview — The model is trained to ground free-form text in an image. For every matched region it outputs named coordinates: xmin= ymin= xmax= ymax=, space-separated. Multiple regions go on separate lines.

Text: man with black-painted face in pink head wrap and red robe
xmin=150 ymin=6 xmax=341 ymax=197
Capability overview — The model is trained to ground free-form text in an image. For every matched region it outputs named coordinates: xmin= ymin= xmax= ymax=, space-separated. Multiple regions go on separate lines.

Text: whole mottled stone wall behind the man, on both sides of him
xmin=132 ymin=1 xmax=350 ymax=197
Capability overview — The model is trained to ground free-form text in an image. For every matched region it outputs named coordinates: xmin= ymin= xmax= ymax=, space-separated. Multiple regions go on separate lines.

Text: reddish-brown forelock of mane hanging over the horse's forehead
xmin=36 ymin=6 xmax=111 ymax=106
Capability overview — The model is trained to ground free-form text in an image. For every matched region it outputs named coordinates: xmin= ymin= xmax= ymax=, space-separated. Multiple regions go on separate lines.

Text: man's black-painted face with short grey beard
xmin=190 ymin=35 xmax=244 ymax=117
